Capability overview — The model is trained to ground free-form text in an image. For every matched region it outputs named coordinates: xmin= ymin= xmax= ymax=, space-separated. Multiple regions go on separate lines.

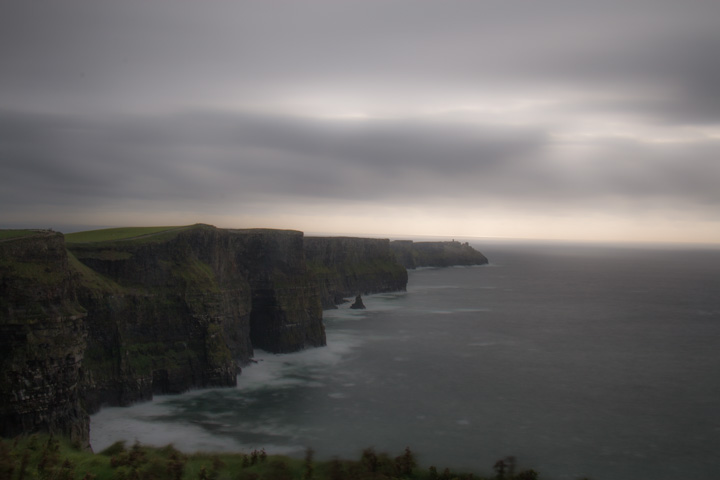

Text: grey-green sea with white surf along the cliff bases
xmin=91 ymin=242 xmax=720 ymax=480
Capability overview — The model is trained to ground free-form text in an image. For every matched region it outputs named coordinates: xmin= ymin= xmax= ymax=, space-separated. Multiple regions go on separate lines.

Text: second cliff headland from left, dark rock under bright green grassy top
xmin=68 ymin=226 xmax=252 ymax=412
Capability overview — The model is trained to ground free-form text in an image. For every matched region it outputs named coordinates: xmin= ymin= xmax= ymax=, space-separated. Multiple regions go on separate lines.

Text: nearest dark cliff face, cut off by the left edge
xmin=0 ymin=232 xmax=88 ymax=444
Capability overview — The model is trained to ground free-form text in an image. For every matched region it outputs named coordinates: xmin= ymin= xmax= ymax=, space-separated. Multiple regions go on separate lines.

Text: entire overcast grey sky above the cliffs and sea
xmin=0 ymin=0 xmax=720 ymax=243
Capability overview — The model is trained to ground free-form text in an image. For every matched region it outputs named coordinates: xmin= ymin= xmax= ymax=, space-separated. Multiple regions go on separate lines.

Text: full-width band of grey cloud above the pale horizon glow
xmin=0 ymin=112 xmax=720 ymax=218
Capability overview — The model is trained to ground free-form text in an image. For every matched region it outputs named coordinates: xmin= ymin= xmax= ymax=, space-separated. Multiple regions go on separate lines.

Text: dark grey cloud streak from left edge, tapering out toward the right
xmin=0 ymin=112 xmax=544 ymax=208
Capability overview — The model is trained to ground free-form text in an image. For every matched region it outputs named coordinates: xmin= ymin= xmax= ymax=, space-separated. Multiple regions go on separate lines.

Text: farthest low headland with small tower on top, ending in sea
xmin=390 ymin=240 xmax=488 ymax=269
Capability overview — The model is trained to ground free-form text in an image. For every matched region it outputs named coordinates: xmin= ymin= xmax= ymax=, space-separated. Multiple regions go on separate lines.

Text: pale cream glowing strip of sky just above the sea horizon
xmin=12 ymin=208 xmax=720 ymax=245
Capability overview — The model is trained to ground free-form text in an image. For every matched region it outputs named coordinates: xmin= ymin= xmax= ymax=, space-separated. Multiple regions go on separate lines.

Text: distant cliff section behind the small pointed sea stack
xmin=305 ymin=237 xmax=408 ymax=308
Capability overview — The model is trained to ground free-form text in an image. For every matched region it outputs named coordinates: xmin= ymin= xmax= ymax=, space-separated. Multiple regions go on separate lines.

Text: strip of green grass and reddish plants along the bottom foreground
xmin=0 ymin=435 xmax=552 ymax=480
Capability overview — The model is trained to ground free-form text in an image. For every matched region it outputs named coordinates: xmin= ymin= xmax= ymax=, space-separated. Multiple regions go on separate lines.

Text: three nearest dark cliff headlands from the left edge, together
xmin=0 ymin=225 xmax=325 ymax=441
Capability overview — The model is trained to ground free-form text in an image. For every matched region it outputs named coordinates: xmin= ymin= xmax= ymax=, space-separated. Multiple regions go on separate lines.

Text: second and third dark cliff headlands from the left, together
xmin=68 ymin=225 xmax=325 ymax=410
